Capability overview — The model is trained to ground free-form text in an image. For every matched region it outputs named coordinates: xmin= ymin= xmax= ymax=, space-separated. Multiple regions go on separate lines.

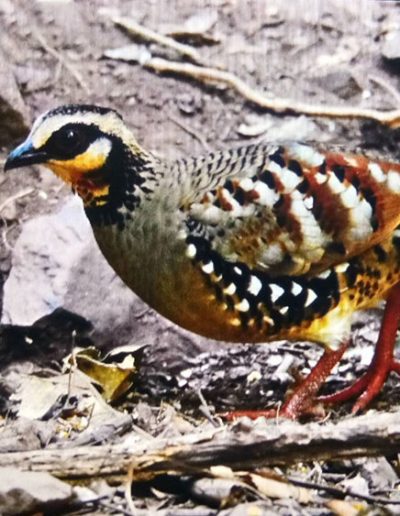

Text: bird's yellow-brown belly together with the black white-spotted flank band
xmin=94 ymin=222 xmax=400 ymax=348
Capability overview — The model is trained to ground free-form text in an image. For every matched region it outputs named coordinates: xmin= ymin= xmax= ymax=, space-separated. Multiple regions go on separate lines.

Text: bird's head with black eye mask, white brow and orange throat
xmin=4 ymin=105 xmax=152 ymax=206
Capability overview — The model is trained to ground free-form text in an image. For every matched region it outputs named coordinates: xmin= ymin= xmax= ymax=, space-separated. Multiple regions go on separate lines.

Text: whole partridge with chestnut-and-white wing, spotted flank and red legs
xmin=5 ymin=104 xmax=400 ymax=419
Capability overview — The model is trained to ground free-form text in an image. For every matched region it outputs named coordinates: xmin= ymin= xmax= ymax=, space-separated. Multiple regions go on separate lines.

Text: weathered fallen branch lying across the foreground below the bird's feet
xmin=0 ymin=412 xmax=400 ymax=479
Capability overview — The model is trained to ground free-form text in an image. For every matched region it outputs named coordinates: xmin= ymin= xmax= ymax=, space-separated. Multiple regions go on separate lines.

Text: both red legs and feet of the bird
xmin=225 ymin=283 xmax=400 ymax=421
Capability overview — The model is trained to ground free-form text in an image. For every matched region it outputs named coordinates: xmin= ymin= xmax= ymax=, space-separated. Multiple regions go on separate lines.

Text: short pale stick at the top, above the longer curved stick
xmin=112 ymin=16 xmax=202 ymax=64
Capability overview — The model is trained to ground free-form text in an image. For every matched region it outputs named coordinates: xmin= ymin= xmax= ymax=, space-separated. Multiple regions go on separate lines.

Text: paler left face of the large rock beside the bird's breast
xmin=2 ymin=199 xmax=92 ymax=325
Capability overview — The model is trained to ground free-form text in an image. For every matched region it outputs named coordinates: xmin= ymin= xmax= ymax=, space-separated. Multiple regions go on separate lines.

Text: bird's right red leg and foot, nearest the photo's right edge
xmin=318 ymin=283 xmax=400 ymax=414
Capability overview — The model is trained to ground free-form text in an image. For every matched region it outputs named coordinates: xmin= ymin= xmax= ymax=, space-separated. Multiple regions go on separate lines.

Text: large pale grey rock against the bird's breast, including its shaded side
xmin=2 ymin=197 xmax=216 ymax=358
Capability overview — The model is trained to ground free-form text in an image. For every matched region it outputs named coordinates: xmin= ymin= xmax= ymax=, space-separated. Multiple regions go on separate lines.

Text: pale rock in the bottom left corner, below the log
xmin=0 ymin=468 xmax=75 ymax=514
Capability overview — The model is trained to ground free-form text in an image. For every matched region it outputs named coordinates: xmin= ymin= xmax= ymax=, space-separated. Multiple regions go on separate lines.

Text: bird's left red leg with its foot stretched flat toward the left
xmin=224 ymin=342 xmax=348 ymax=421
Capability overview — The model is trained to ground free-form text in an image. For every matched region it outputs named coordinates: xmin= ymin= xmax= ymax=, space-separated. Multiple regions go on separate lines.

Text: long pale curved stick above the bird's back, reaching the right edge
xmin=143 ymin=57 xmax=400 ymax=128
